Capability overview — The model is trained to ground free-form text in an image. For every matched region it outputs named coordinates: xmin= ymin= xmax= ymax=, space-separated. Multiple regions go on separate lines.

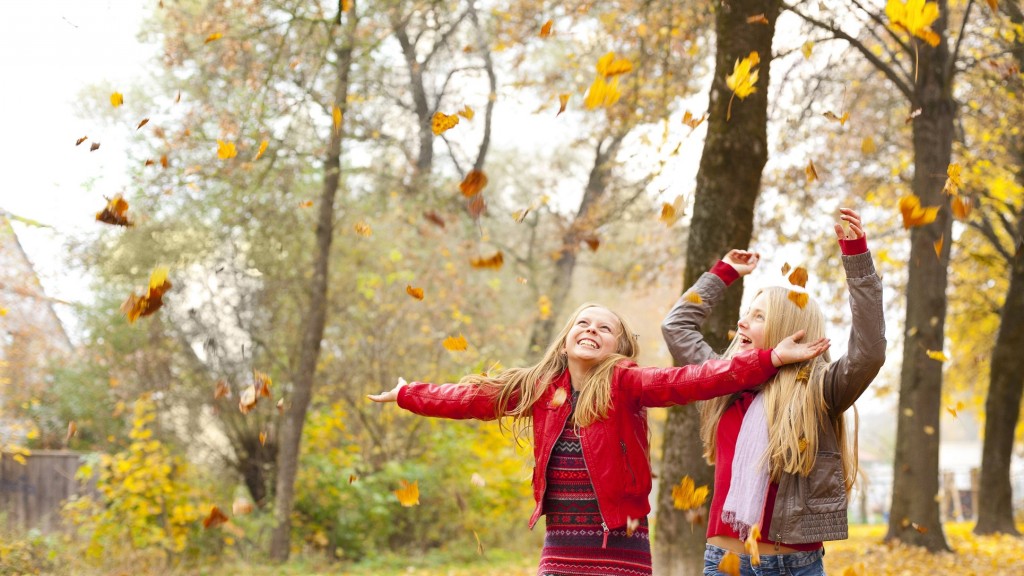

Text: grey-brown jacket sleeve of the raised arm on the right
xmin=823 ymin=252 xmax=886 ymax=416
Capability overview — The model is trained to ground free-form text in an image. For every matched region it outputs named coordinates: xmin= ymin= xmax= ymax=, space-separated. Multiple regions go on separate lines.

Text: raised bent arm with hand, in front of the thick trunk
xmin=662 ymin=250 xmax=761 ymax=365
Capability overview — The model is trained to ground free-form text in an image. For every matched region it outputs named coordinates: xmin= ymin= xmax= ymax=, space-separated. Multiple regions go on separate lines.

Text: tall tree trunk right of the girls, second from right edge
xmin=886 ymin=1 xmax=955 ymax=551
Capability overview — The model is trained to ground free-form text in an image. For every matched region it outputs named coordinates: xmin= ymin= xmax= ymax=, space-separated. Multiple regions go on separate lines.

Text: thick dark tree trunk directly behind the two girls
xmin=653 ymin=0 xmax=780 ymax=576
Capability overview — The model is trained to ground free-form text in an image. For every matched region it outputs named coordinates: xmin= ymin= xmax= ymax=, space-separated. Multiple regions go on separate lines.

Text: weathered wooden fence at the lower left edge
xmin=0 ymin=450 xmax=88 ymax=532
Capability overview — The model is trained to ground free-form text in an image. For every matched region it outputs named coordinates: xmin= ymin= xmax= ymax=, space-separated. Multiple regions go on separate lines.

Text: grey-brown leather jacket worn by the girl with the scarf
xmin=662 ymin=252 xmax=886 ymax=544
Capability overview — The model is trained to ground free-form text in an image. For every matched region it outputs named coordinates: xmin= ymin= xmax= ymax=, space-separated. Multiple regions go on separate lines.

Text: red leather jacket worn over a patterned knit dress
xmin=398 ymin=351 xmax=776 ymax=539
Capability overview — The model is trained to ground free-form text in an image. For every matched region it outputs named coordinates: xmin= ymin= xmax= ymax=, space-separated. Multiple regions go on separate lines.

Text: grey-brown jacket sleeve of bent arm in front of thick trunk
xmin=662 ymin=272 xmax=726 ymax=366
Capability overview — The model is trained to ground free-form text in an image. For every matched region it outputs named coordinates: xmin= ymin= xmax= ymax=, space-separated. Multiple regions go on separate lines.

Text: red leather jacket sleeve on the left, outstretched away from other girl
xmin=398 ymin=382 xmax=498 ymax=420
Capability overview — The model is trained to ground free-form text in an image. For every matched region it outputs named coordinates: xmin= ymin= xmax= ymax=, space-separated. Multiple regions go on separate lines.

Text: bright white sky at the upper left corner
xmin=0 ymin=0 xmax=155 ymax=323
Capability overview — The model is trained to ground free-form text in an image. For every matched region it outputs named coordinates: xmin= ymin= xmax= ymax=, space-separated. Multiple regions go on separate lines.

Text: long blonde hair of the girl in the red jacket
xmin=459 ymin=302 xmax=640 ymax=442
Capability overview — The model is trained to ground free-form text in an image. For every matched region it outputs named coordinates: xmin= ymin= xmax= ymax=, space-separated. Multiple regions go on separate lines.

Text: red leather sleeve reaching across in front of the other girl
xmin=622 ymin=349 xmax=778 ymax=408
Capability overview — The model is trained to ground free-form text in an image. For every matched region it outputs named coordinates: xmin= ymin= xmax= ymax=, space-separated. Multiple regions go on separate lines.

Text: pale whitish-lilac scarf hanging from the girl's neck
xmin=722 ymin=393 xmax=768 ymax=540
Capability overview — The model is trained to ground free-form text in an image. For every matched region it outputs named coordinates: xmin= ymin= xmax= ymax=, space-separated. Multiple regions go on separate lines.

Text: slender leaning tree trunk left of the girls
xmin=270 ymin=2 xmax=356 ymax=562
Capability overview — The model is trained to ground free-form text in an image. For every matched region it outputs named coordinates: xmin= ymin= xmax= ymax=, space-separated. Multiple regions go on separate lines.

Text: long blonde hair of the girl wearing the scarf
xmin=700 ymin=286 xmax=857 ymax=491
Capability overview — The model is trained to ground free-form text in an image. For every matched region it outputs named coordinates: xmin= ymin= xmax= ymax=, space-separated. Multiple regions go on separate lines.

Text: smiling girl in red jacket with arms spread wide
xmin=370 ymin=303 xmax=828 ymax=575
